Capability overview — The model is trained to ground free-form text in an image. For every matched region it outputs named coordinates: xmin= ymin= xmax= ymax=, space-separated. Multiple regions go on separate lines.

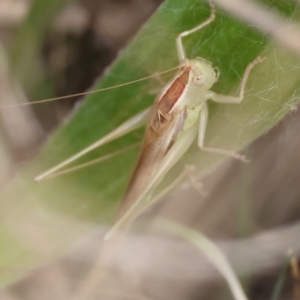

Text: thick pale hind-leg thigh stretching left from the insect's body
xmin=34 ymin=108 xmax=150 ymax=182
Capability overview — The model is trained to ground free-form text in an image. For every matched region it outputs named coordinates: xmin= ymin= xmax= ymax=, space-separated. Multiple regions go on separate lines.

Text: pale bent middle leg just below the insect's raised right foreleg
xmin=198 ymin=103 xmax=247 ymax=161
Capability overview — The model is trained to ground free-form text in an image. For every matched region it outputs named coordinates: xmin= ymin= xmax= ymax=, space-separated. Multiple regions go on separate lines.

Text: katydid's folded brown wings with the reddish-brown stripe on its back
xmin=116 ymin=67 xmax=190 ymax=220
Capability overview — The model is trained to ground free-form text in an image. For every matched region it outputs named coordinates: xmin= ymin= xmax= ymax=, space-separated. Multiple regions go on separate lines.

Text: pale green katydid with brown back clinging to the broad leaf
xmin=35 ymin=2 xmax=264 ymax=239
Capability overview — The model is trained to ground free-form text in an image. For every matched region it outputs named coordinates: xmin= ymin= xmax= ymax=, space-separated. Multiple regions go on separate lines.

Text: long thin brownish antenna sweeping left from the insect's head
xmin=0 ymin=66 xmax=179 ymax=109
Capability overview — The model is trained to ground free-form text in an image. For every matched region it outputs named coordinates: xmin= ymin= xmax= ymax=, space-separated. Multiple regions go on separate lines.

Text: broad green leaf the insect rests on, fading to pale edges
xmin=0 ymin=0 xmax=300 ymax=281
